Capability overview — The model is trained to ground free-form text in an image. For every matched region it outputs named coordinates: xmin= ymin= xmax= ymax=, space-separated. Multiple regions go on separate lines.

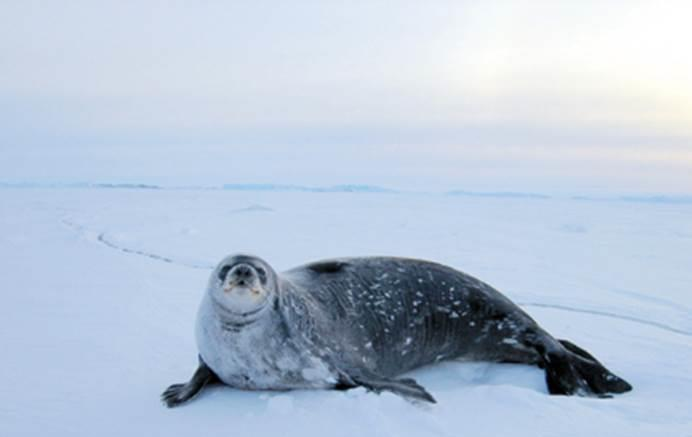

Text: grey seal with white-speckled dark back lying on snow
xmin=162 ymin=255 xmax=632 ymax=407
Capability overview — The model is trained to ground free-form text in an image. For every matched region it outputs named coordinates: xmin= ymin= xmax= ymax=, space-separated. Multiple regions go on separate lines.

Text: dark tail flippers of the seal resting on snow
xmin=543 ymin=340 xmax=632 ymax=397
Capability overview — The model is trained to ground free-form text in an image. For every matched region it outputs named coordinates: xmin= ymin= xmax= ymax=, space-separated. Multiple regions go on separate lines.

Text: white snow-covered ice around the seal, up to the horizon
xmin=0 ymin=188 xmax=692 ymax=437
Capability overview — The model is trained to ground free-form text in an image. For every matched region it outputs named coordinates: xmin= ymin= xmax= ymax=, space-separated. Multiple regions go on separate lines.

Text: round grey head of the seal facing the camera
xmin=207 ymin=255 xmax=278 ymax=317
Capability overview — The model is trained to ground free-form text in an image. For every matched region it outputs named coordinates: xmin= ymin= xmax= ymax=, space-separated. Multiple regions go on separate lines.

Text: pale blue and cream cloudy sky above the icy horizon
xmin=0 ymin=0 xmax=692 ymax=193
